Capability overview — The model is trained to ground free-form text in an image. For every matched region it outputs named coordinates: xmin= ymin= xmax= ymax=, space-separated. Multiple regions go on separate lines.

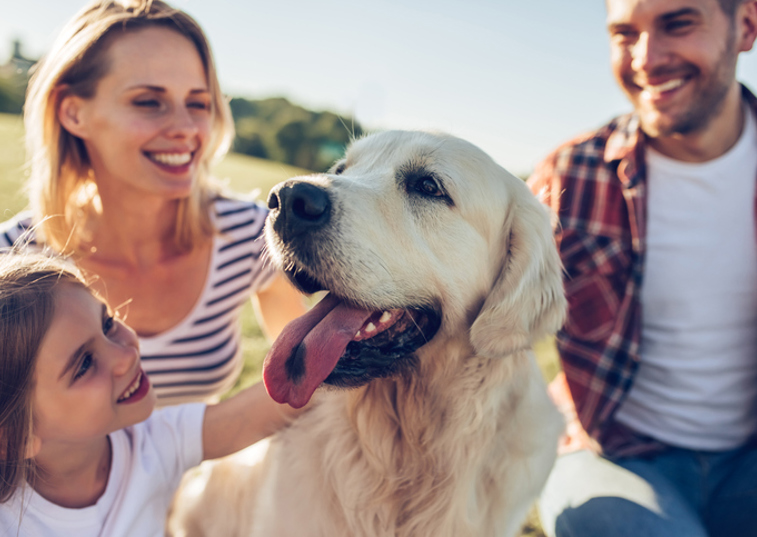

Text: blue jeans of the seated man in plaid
xmin=539 ymin=446 xmax=757 ymax=537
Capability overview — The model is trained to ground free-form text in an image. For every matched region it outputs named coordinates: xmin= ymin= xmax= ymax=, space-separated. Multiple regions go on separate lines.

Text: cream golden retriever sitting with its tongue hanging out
xmin=171 ymin=131 xmax=566 ymax=537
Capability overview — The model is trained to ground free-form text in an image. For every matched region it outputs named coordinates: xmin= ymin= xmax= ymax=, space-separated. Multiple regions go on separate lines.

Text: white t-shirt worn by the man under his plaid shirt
xmin=616 ymin=104 xmax=757 ymax=450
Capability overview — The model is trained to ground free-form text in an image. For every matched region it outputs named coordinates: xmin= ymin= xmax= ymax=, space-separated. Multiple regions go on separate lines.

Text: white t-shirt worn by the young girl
xmin=0 ymin=403 xmax=205 ymax=537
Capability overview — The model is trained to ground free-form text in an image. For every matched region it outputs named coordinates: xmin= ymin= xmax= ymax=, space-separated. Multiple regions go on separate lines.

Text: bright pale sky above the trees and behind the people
xmin=0 ymin=0 xmax=757 ymax=173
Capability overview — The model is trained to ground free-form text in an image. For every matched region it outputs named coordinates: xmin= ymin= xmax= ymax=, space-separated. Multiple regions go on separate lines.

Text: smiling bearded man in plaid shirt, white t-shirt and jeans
xmin=529 ymin=0 xmax=757 ymax=537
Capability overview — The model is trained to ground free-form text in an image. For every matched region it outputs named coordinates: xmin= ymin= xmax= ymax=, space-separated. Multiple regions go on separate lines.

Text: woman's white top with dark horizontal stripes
xmin=0 ymin=198 xmax=276 ymax=405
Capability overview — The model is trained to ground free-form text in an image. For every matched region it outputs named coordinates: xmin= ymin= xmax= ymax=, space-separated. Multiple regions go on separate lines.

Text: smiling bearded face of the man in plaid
xmin=607 ymin=0 xmax=739 ymax=138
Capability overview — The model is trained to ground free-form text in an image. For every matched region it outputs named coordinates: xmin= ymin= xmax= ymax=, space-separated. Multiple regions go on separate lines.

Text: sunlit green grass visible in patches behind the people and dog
xmin=0 ymin=114 xmax=559 ymax=537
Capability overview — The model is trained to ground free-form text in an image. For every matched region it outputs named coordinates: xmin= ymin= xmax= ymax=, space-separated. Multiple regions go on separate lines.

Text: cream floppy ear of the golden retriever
xmin=471 ymin=189 xmax=567 ymax=357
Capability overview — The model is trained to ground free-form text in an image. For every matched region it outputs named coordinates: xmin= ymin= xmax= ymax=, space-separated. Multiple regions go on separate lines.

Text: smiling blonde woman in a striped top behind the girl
xmin=0 ymin=0 xmax=305 ymax=405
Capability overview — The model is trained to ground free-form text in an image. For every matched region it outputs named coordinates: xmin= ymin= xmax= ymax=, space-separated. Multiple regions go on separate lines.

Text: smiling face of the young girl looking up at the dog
xmin=33 ymin=283 xmax=156 ymax=449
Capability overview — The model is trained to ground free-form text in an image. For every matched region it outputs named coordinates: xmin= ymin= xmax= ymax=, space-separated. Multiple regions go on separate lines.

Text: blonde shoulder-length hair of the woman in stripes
xmin=24 ymin=0 xmax=234 ymax=252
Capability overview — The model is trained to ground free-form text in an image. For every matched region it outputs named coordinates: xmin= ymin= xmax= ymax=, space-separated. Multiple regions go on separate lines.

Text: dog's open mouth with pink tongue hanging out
xmin=263 ymin=272 xmax=441 ymax=408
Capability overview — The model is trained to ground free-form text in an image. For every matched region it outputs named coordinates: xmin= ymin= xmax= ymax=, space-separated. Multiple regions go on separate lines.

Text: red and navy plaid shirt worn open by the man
xmin=529 ymin=87 xmax=757 ymax=456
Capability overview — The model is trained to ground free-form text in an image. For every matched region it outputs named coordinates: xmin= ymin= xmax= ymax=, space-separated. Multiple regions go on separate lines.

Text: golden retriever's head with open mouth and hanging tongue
xmin=264 ymin=131 xmax=565 ymax=406
